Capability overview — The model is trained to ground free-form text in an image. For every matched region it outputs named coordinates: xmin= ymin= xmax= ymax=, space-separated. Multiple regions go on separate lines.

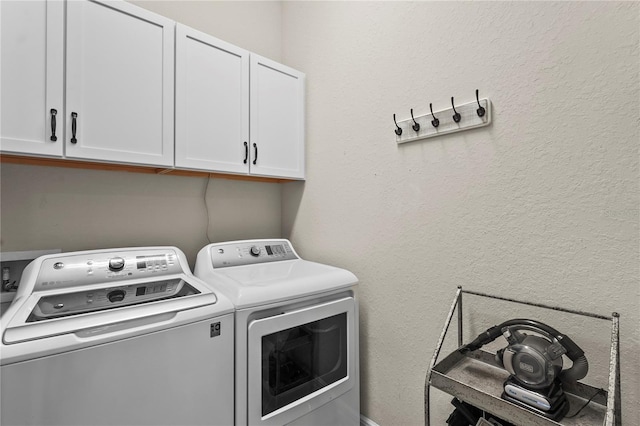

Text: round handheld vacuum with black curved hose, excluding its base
xmin=459 ymin=319 xmax=589 ymax=389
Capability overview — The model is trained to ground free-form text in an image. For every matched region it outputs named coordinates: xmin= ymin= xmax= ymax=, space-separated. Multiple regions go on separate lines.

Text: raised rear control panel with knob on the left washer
xmin=34 ymin=249 xmax=184 ymax=292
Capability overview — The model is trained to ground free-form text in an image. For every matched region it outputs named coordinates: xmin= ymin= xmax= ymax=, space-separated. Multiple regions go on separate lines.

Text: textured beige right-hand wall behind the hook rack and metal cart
xmin=282 ymin=2 xmax=640 ymax=425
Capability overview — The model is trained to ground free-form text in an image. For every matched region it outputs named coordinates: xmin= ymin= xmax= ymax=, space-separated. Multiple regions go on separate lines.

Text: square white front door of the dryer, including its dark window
xmin=247 ymin=297 xmax=357 ymax=425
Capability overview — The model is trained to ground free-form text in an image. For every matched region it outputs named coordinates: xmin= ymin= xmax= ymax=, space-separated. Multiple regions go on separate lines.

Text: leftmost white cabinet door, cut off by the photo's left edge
xmin=0 ymin=0 xmax=64 ymax=156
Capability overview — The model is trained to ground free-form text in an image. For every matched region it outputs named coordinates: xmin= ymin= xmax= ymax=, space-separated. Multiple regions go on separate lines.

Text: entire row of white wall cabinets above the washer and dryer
xmin=0 ymin=0 xmax=305 ymax=179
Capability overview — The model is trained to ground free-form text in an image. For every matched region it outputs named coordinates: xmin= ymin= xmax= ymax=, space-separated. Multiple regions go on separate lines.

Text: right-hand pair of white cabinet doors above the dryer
xmin=175 ymin=24 xmax=305 ymax=179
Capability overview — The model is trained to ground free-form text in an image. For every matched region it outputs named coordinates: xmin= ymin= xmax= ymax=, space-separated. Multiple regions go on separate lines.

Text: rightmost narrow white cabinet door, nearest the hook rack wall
xmin=249 ymin=55 xmax=305 ymax=179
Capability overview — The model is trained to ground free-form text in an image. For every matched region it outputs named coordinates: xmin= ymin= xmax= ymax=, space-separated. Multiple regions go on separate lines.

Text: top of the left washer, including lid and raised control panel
xmin=0 ymin=247 xmax=233 ymax=345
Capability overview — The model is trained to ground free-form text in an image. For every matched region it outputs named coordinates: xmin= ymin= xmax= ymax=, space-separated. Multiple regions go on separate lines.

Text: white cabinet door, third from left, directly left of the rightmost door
xmin=175 ymin=24 xmax=249 ymax=174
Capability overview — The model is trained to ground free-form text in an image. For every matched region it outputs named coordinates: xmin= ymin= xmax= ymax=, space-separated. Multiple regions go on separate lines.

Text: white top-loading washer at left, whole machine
xmin=0 ymin=247 xmax=234 ymax=426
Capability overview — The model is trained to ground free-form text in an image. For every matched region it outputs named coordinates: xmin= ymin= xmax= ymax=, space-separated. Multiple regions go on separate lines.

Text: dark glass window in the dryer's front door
xmin=262 ymin=313 xmax=347 ymax=416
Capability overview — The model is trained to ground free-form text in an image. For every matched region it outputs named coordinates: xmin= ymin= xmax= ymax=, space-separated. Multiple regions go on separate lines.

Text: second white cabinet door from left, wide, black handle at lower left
xmin=66 ymin=0 xmax=175 ymax=166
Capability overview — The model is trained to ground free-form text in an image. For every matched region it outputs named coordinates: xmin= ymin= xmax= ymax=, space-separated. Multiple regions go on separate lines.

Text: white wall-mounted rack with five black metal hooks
xmin=393 ymin=89 xmax=491 ymax=144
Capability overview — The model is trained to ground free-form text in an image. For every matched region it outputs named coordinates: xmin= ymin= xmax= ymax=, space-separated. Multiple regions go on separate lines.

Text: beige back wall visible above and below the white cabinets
xmin=0 ymin=0 xmax=281 ymax=267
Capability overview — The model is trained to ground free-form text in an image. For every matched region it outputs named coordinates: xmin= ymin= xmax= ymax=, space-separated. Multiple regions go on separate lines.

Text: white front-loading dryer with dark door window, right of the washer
xmin=194 ymin=239 xmax=360 ymax=426
